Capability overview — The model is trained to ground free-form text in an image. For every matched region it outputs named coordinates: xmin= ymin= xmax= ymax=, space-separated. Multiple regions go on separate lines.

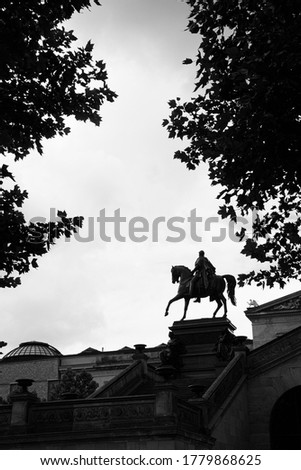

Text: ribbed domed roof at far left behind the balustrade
xmin=2 ymin=341 xmax=62 ymax=361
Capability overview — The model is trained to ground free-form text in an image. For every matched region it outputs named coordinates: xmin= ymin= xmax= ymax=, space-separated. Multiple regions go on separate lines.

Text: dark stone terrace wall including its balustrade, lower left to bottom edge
xmin=0 ymin=392 xmax=213 ymax=450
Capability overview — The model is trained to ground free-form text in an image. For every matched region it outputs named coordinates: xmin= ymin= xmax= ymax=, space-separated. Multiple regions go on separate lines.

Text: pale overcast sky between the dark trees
xmin=0 ymin=0 xmax=300 ymax=354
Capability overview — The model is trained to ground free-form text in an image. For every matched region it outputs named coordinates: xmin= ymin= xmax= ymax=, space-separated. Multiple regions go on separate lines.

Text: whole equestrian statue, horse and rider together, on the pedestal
xmin=165 ymin=250 xmax=236 ymax=321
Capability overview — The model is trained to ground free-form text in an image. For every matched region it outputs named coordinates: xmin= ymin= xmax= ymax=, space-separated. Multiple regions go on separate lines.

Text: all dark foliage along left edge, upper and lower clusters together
xmin=0 ymin=0 xmax=117 ymax=287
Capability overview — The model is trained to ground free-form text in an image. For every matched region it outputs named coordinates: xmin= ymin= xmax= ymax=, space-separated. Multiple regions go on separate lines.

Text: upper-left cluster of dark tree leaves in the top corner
xmin=0 ymin=0 xmax=116 ymax=159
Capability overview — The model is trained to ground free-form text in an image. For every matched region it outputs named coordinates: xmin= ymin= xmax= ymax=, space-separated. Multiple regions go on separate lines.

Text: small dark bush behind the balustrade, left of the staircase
xmin=51 ymin=369 xmax=98 ymax=400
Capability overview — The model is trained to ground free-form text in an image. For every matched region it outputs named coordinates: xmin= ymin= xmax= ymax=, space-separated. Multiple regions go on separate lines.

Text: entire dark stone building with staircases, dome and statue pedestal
xmin=0 ymin=291 xmax=301 ymax=450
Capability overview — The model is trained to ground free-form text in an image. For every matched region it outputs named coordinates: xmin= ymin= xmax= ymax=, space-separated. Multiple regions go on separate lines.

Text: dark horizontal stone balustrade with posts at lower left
xmin=0 ymin=382 xmax=204 ymax=440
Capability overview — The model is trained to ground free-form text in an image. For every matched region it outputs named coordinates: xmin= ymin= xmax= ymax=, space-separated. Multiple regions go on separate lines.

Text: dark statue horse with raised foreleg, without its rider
xmin=165 ymin=266 xmax=236 ymax=321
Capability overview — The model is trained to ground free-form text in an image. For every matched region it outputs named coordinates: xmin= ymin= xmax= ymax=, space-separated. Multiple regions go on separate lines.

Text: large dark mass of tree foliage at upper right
xmin=163 ymin=0 xmax=301 ymax=287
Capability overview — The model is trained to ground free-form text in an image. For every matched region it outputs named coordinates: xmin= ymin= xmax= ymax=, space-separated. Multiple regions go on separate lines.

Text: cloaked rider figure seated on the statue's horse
xmin=190 ymin=250 xmax=216 ymax=302
